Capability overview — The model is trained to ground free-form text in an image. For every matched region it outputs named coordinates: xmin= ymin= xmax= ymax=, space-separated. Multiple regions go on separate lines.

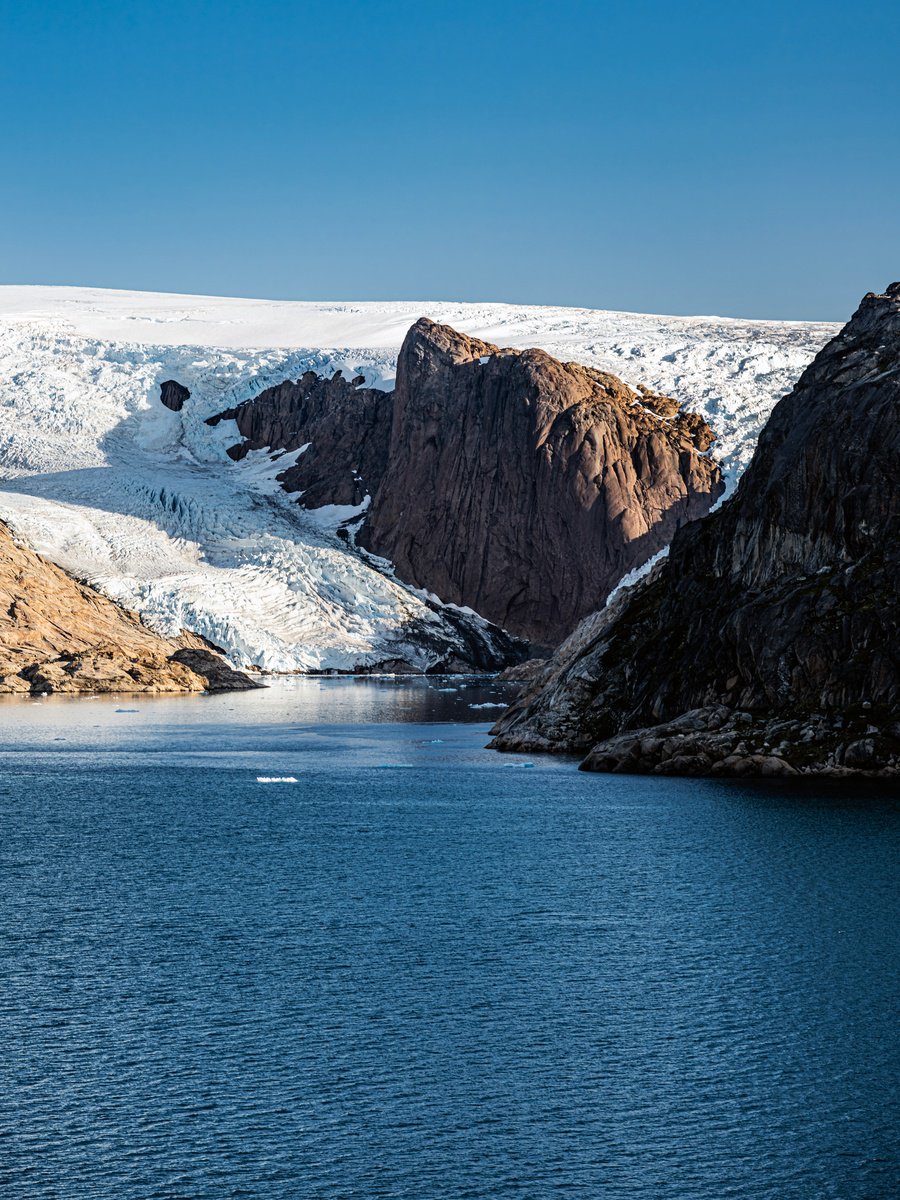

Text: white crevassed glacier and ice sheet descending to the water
xmin=0 ymin=287 xmax=838 ymax=671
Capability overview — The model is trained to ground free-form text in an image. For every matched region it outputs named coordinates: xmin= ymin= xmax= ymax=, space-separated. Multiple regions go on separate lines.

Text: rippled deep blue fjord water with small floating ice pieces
xmin=0 ymin=679 xmax=900 ymax=1200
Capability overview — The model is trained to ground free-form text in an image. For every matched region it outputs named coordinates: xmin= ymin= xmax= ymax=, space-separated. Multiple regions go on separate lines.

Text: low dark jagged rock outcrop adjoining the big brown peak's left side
xmin=213 ymin=371 xmax=392 ymax=509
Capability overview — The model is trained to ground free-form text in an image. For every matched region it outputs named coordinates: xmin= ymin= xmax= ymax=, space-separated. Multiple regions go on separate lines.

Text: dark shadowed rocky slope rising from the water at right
xmin=494 ymin=284 xmax=900 ymax=774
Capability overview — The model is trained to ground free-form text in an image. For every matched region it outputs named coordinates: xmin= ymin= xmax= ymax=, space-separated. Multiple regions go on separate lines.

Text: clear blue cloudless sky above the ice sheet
xmin=0 ymin=0 xmax=900 ymax=319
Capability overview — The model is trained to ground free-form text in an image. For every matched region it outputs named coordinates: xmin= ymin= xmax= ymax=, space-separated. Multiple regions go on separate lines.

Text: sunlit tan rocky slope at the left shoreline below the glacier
xmin=0 ymin=523 xmax=259 ymax=694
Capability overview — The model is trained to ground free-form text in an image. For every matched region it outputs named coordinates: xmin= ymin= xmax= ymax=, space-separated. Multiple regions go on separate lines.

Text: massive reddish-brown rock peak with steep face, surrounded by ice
xmin=358 ymin=319 xmax=722 ymax=644
